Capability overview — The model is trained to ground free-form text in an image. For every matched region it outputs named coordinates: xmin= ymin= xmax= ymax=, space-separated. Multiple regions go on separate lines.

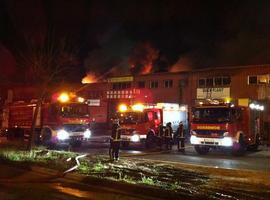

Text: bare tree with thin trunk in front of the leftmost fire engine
xmin=16 ymin=34 xmax=77 ymax=150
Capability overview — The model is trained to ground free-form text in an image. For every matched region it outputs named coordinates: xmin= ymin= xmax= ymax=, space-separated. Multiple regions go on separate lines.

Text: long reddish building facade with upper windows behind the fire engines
xmin=80 ymin=65 xmax=270 ymax=141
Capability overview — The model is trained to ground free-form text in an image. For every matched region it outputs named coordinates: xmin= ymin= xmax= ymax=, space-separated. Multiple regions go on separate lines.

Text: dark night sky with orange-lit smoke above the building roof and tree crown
xmin=0 ymin=0 xmax=270 ymax=81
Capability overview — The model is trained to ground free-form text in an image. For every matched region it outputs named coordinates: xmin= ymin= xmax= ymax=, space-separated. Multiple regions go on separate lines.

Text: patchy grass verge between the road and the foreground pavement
xmin=0 ymin=149 xmax=270 ymax=199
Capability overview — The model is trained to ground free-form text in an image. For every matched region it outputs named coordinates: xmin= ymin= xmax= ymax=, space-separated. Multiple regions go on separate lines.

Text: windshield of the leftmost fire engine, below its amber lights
xmin=59 ymin=103 xmax=89 ymax=117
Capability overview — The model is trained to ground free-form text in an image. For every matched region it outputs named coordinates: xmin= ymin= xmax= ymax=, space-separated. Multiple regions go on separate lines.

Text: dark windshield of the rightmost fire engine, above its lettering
xmin=192 ymin=108 xmax=231 ymax=123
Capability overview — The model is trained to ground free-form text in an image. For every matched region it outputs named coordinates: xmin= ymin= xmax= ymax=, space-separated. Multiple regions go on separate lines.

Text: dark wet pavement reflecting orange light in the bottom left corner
xmin=0 ymin=165 xmax=155 ymax=200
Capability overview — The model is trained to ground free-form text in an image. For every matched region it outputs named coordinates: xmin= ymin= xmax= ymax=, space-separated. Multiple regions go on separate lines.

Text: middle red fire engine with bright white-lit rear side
xmin=117 ymin=103 xmax=187 ymax=146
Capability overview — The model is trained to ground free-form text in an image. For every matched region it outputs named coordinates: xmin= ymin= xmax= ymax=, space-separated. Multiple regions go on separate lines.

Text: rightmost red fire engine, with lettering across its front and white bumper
xmin=190 ymin=99 xmax=264 ymax=154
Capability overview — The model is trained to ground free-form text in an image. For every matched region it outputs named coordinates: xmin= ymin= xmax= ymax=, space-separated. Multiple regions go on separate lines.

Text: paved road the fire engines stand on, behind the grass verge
xmin=74 ymin=138 xmax=270 ymax=171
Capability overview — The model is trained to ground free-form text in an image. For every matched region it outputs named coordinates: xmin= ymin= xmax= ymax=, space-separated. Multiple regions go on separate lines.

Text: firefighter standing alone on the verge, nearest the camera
xmin=109 ymin=120 xmax=121 ymax=161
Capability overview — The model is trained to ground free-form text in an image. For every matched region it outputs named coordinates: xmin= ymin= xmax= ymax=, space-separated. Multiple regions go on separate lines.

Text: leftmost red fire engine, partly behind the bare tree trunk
xmin=2 ymin=93 xmax=91 ymax=145
